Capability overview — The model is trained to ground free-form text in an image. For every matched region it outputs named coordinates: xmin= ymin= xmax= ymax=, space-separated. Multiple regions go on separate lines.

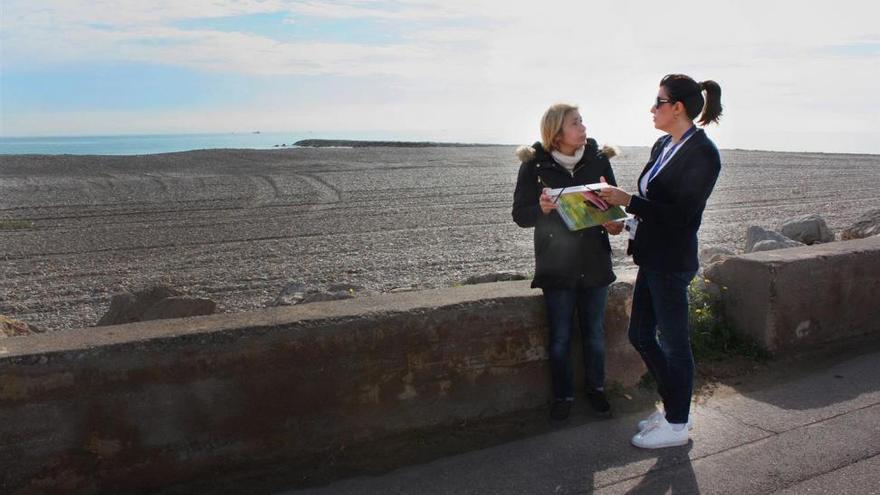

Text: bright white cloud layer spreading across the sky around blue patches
xmin=0 ymin=0 xmax=880 ymax=151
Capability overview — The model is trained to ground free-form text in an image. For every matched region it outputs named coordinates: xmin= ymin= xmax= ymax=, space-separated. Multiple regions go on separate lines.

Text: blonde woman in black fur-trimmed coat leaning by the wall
xmin=513 ymin=104 xmax=622 ymax=420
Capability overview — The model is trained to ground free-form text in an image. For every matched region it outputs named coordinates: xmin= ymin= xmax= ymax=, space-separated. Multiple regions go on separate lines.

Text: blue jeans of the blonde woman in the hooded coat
xmin=544 ymin=286 xmax=608 ymax=399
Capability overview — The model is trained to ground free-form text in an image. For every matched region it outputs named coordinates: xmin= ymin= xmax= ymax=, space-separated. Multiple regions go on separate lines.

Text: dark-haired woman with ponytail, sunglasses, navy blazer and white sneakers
xmin=600 ymin=74 xmax=721 ymax=449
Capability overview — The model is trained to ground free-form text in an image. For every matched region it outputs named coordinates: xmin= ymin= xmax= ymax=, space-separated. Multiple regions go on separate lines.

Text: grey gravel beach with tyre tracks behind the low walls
xmin=0 ymin=146 xmax=880 ymax=330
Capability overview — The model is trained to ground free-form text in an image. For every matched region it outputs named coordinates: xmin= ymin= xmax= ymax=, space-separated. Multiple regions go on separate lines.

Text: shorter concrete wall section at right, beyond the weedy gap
xmin=707 ymin=236 xmax=880 ymax=351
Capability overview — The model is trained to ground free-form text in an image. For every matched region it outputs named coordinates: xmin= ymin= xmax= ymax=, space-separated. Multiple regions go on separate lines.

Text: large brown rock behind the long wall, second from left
xmin=98 ymin=285 xmax=217 ymax=326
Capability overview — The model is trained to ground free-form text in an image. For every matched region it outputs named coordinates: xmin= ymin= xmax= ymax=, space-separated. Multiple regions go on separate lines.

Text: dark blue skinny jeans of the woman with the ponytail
xmin=629 ymin=268 xmax=696 ymax=423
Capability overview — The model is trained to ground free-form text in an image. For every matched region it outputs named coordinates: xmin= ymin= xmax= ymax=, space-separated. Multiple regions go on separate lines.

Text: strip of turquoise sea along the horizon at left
xmin=0 ymin=132 xmax=420 ymax=155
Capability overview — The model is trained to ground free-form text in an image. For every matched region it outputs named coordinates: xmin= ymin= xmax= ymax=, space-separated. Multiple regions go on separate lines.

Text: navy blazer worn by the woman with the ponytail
xmin=627 ymin=129 xmax=721 ymax=272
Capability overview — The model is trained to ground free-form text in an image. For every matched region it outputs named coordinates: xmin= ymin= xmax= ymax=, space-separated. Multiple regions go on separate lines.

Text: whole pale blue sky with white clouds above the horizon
xmin=0 ymin=0 xmax=880 ymax=154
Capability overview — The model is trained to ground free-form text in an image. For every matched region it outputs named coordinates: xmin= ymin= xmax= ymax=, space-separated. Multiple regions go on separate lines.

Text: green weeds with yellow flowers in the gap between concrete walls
xmin=688 ymin=279 xmax=770 ymax=361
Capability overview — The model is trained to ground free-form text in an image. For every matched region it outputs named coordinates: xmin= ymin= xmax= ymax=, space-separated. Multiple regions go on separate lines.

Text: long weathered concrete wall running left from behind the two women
xmin=0 ymin=276 xmax=644 ymax=493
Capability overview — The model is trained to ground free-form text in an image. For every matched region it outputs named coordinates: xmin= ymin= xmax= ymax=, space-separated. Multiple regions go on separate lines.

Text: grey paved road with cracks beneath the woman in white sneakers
xmin=284 ymin=346 xmax=880 ymax=495
